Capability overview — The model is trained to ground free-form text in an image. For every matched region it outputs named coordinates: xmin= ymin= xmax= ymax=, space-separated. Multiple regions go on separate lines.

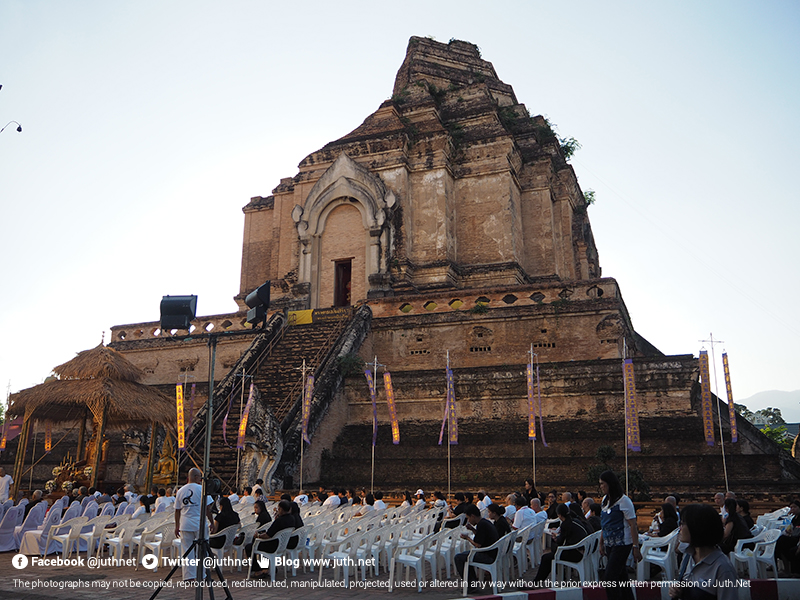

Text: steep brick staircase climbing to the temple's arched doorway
xmin=203 ymin=318 xmax=349 ymax=489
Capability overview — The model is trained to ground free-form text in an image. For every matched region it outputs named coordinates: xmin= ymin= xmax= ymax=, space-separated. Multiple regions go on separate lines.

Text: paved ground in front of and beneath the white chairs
xmin=0 ymin=552 xmax=533 ymax=600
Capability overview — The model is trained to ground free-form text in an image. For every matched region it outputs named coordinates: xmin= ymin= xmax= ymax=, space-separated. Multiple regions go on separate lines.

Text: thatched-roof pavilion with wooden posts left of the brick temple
xmin=8 ymin=344 xmax=176 ymax=492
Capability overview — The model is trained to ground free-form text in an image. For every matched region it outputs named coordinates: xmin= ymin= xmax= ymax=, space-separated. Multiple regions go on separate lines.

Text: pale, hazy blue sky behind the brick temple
xmin=0 ymin=0 xmax=800 ymax=420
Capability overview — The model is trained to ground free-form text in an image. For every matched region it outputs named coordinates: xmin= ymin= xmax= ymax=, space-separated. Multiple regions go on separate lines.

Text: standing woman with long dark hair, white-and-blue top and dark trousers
xmin=600 ymin=471 xmax=642 ymax=600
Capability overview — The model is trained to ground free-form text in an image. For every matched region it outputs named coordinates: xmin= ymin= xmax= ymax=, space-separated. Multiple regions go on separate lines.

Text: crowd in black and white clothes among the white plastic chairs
xmin=0 ymin=469 xmax=800 ymax=599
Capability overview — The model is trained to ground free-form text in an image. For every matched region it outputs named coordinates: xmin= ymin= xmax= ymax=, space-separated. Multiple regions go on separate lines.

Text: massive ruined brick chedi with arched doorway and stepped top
xmin=104 ymin=37 xmax=800 ymax=491
